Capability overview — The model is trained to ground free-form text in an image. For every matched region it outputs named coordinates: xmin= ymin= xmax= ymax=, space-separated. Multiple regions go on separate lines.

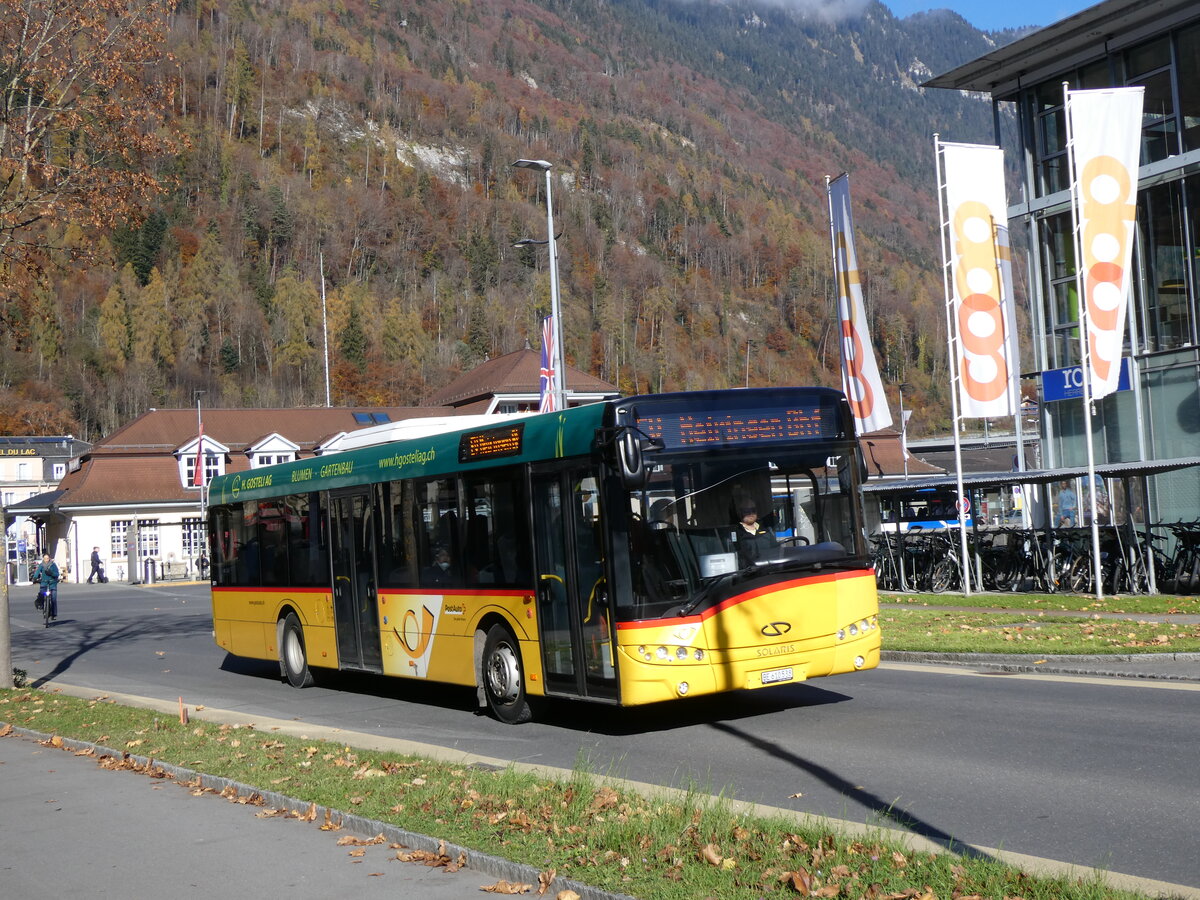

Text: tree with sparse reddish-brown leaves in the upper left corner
xmin=0 ymin=0 xmax=176 ymax=289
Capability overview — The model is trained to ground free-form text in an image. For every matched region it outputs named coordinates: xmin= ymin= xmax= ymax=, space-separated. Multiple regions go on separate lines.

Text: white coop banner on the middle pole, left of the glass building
xmin=940 ymin=143 xmax=1020 ymax=419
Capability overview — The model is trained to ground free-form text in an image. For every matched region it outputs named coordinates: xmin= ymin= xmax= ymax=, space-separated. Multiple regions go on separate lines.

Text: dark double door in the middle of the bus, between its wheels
xmin=329 ymin=493 xmax=383 ymax=672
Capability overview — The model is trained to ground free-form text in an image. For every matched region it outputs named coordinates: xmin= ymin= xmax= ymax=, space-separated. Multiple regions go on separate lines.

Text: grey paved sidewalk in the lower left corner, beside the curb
xmin=0 ymin=728 xmax=617 ymax=900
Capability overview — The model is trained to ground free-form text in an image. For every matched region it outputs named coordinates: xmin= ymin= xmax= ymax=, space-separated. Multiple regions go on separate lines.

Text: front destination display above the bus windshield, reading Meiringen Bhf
xmin=637 ymin=403 xmax=840 ymax=448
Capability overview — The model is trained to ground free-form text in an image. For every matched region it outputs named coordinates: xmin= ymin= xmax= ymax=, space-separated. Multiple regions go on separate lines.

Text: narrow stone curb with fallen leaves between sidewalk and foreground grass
xmin=7 ymin=721 xmax=637 ymax=900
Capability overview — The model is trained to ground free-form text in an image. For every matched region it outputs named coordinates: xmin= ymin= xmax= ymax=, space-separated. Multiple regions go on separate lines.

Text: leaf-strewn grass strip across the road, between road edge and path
xmin=880 ymin=607 xmax=1200 ymax=655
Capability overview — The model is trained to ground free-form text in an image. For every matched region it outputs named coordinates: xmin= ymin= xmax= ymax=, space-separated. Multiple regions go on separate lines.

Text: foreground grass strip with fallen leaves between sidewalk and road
xmin=0 ymin=689 xmax=1161 ymax=900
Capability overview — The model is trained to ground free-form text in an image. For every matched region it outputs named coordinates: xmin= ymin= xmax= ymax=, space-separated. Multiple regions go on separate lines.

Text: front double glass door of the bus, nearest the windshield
xmin=533 ymin=466 xmax=617 ymax=700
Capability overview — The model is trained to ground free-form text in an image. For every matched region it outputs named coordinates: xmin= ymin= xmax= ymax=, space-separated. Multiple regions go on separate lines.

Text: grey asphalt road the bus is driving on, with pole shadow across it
xmin=11 ymin=584 xmax=1200 ymax=887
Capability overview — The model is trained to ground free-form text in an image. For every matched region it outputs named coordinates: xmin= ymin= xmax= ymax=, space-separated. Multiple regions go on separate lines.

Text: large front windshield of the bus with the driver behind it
xmin=618 ymin=444 xmax=862 ymax=619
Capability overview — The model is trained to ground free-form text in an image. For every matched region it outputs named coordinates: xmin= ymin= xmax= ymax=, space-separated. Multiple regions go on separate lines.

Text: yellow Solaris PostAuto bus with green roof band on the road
xmin=208 ymin=388 xmax=880 ymax=724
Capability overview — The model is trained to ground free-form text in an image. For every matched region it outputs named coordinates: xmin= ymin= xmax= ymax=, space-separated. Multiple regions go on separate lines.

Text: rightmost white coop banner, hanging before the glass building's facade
xmin=1067 ymin=86 xmax=1144 ymax=398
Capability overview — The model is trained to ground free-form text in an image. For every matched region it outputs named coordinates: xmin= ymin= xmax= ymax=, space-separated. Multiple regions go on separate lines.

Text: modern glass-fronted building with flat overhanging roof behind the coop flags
xmin=925 ymin=0 xmax=1200 ymax=522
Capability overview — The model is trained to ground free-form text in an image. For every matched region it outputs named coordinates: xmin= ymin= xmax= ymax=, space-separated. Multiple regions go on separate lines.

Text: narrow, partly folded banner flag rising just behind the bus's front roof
xmin=829 ymin=175 xmax=892 ymax=433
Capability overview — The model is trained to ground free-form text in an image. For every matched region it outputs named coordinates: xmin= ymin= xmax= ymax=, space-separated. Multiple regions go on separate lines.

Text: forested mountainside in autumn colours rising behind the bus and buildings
xmin=0 ymin=0 xmax=1012 ymax=439
